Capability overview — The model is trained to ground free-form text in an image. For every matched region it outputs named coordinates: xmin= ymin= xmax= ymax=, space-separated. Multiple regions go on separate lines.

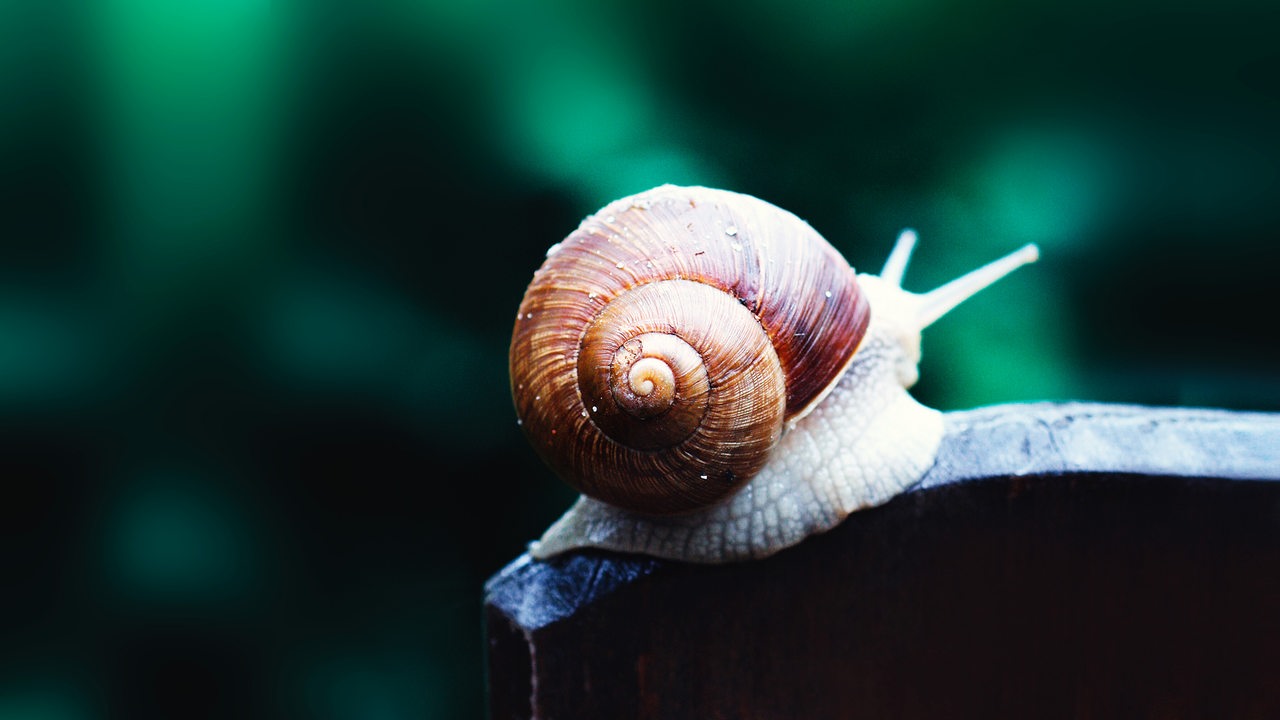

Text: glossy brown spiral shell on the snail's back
xmin=511 ymin=186 xmax=869 ymax=514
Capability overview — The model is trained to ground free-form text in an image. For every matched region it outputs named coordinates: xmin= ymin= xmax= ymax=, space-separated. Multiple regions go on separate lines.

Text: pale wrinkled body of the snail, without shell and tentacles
xmin=529 ymin=275 xmax=942 ymax=562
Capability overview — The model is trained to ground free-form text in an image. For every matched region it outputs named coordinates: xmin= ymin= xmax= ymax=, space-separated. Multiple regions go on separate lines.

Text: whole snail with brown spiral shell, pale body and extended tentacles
xmin=509 ymin=186 xmax=1038 ymax=562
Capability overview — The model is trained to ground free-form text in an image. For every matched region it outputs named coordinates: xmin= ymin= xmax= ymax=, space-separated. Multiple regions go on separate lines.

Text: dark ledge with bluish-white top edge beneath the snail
xmin=485 ymin=404 xmax=1280 ymax=720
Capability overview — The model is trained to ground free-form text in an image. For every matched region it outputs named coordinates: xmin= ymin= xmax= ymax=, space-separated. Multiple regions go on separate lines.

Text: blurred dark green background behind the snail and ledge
xmin=0 ymin=0 xmax=1280 ymax=720
